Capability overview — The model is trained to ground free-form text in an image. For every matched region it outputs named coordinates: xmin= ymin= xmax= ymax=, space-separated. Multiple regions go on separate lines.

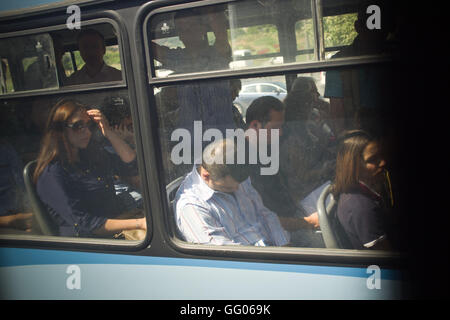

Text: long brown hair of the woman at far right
xmin=333 ymin=130 xmax=375 ymax=196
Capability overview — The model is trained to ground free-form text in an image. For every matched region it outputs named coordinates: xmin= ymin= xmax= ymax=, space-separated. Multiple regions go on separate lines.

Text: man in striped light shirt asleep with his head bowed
xmin=174 ymin=140 xmax=289 ymax=246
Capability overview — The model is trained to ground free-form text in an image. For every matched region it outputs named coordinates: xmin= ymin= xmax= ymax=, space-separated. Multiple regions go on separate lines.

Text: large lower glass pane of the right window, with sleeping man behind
xmin=155 ymin=59 xmax=396 ymax=249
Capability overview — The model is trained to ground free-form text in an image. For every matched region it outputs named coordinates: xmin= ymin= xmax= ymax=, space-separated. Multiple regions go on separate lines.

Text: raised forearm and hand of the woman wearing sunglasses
xmin=87 ymin=109 xmax=136 ymax=163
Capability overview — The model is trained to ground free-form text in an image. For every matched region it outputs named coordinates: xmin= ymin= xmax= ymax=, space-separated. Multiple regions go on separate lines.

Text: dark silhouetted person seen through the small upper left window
xmin=67 ymin=29 xmax=122 ymax=85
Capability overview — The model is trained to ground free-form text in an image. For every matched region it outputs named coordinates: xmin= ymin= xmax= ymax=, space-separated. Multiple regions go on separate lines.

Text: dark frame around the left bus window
xmin=0 ymin=8 xmax=154 ymax=252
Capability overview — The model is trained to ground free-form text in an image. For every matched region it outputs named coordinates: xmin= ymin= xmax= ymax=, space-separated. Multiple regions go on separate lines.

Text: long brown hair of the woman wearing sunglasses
xmin=33 ymin=99 xmax=87 ymax=183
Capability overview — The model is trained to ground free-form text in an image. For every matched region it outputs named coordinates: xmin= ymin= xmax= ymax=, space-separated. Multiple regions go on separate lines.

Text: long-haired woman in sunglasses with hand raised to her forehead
xmin=33 ymin=100 xmax=147 ymax=237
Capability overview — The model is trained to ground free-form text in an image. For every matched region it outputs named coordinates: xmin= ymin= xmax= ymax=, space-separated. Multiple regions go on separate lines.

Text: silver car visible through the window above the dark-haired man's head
xmin=233 ymin=82 xmax=287 ymax=119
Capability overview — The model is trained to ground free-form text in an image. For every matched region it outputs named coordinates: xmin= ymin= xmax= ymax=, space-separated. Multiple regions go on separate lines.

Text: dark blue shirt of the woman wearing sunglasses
xmin=37 ymin=150 xmax=137 ymax=236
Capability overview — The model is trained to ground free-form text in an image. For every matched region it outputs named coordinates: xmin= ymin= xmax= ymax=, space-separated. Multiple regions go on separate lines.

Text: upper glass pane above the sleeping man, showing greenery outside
xmin=147 ymin=0 xmax=315 ymax=77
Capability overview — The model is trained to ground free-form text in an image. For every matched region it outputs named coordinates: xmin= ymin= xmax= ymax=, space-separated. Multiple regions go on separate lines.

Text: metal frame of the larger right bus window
xmin=139 ymin=0 xmax=405 ymax=268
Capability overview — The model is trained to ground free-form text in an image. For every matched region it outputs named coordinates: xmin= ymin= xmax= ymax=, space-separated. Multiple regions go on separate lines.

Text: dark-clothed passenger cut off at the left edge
xmin=0 ymin=139 xmax=33 ymax=233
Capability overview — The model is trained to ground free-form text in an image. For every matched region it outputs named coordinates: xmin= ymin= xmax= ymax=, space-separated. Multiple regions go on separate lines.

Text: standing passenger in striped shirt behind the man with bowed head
xmin=152 ymin=9 xmax=236 ymax=160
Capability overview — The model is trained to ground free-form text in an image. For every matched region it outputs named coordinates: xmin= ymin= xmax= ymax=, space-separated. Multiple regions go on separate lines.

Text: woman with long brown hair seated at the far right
xmin=333 ymin=130 xmax=390 ymax=250
